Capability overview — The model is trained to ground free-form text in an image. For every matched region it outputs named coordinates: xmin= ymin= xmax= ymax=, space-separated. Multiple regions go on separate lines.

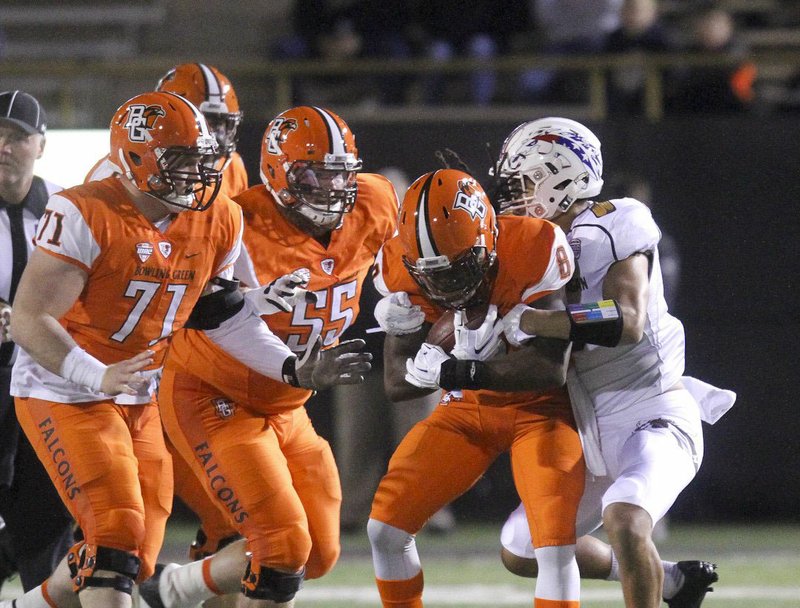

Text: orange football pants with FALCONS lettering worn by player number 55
xmin=159 ymin=369 xmax=342 ymax=578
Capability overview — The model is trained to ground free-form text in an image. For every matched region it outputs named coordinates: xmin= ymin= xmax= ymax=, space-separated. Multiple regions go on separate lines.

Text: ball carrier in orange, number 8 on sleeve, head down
xmin=367 ymin=169 xmax=584 ymax=608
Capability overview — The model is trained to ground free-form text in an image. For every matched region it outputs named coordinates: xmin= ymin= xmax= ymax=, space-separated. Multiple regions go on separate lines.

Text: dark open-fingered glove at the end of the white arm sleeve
xmin=294 ymin=337 xmax=372 ymax=391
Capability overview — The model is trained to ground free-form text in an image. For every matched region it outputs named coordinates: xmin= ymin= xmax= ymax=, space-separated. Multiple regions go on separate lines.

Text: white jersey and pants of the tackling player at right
xmin=501 ymin=198 xmax=736 ymax=558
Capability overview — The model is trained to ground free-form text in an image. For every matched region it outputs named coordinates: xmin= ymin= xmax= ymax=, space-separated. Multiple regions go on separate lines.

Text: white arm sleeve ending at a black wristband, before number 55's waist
xmin=205 ymin=306 xmax=295 ymax=382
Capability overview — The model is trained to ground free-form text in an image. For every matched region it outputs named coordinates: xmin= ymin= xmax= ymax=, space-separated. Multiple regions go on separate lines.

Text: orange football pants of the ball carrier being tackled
xmin=370 ymin=401 xmax=584 ymax=547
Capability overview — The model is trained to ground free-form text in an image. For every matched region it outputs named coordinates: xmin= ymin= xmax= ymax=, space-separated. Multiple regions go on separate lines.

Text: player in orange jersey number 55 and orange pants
xmin=140 ymin=106 xmax=398 ymax=608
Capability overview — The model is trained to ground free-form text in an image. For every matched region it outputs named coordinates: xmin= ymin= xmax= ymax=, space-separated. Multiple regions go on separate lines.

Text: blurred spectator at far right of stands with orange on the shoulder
xmin=668 ymin=6 xmax=756 ymax=112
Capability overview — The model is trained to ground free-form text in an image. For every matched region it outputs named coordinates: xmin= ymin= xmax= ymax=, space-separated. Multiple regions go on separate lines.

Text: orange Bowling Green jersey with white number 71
xmin=14 ymin=177 xmax=242 ymax=394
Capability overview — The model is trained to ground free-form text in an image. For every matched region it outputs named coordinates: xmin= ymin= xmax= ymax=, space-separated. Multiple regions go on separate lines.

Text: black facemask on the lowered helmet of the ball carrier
xmin=403 ymin=247 xmax=497 ymax=309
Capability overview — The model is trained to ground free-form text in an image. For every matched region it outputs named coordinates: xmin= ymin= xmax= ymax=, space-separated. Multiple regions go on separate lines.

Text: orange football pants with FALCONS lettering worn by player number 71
xmin=16 ymin=397 xmax=172 ymax=581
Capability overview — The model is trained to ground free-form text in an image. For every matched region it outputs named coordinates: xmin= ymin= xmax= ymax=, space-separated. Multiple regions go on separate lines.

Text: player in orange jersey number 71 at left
xmin=0 ymin=92 xmax=361 ymax=608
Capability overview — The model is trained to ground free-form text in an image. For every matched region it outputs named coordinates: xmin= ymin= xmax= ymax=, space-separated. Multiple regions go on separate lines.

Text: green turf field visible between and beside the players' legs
xmin=0 ymin=523 xmax=800 ymax=608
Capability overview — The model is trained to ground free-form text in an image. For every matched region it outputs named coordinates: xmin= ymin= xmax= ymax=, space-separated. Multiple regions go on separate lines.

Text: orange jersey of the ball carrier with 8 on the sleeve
xmin=375 ymin=216 xmax=574 ymax=405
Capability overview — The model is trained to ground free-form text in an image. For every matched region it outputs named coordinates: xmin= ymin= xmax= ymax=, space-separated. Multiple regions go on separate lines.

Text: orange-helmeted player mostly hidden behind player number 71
xmin=84 ymin=63 xmax=247 ymax=197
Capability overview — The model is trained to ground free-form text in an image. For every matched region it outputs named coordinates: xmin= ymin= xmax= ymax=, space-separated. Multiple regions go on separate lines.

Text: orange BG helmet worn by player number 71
xmin=111 ymin=92 xmax=221 ymax=211
